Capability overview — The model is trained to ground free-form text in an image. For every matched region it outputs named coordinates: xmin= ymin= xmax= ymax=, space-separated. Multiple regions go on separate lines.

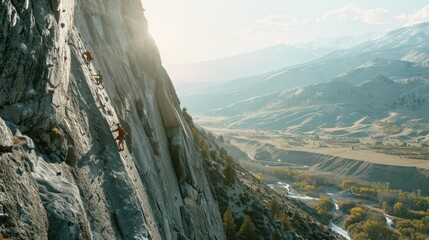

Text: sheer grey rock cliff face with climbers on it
xmin=0 ymin=0 xmax=225 ymax=239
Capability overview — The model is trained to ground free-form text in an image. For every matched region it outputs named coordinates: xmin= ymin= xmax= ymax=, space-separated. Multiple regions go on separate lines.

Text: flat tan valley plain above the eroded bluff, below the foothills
xmin=202 ymin=123 xmax=429 ymax=166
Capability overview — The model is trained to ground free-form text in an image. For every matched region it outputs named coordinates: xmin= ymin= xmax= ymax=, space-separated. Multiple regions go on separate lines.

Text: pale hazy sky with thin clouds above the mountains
xmin=142 ymin=0 xmax=429 ymax=65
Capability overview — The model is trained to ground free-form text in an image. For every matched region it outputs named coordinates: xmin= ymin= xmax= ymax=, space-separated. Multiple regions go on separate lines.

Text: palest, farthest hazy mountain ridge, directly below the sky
xmin=166 ymin=33 xmax=375 ymax=97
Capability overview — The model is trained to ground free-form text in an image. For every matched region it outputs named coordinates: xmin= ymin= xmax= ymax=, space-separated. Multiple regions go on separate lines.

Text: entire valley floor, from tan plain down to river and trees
xmin=205 ymin=123 xmax=429 ymax=239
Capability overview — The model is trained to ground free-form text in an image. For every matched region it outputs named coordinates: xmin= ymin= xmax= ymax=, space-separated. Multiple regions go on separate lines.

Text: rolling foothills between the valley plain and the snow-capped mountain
xmin=203 ymin=76 xmax=429 ymax=142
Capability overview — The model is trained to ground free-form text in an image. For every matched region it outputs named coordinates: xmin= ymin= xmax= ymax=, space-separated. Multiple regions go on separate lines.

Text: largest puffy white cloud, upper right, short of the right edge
xmin=316 ymin=3 xmax=390 ymax=24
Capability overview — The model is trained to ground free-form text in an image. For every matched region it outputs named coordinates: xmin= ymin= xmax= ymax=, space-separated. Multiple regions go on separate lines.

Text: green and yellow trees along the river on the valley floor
xmin=234 ymin=156 xmax=429 ymax=240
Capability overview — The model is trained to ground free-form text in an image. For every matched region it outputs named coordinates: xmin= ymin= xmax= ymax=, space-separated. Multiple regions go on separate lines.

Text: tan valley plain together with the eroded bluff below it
xmin=202 ymin=127 xmax=429 ymax=192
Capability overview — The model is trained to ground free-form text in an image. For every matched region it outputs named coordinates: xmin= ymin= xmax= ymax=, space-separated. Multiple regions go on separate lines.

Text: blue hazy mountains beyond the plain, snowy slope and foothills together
xmin=187 ymin=23 xmax=429 ymax=141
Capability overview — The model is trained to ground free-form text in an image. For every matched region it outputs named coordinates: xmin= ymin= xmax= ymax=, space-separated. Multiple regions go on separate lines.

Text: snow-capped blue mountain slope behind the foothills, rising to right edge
xmin=182 ymin=23 xmax=429 ymax=113
